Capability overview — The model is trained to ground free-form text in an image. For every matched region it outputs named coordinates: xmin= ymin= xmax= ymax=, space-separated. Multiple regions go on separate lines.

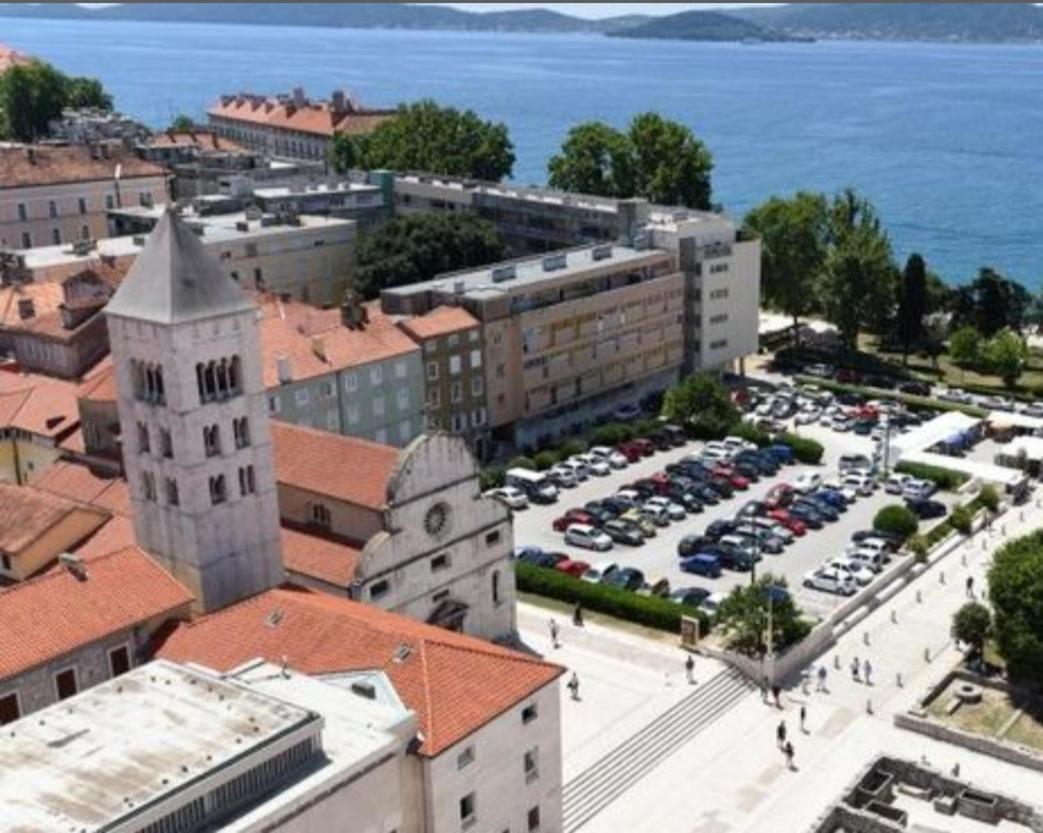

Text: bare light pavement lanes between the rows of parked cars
xmin=514 ymin=417 xmax=952 ymax=616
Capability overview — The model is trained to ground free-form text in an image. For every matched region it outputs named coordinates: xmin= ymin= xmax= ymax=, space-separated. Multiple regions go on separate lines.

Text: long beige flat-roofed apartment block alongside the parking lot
xmin=383 ymin=244 xmax=685 ymax=447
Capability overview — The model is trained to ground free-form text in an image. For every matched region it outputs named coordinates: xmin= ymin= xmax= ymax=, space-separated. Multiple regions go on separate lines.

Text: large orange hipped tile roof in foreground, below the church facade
xmin=159 ymin=587 xmax=563 ymax=757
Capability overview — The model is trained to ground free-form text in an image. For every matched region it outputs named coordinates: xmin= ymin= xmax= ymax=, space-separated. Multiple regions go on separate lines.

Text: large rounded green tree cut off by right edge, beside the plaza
xmin=989 ymin=530 xmax=1043 ymax=686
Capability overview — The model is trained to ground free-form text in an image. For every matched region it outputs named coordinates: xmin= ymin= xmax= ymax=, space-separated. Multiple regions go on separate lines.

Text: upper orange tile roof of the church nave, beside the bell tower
xmin=271 ymin=421 xmax=401 ymax=510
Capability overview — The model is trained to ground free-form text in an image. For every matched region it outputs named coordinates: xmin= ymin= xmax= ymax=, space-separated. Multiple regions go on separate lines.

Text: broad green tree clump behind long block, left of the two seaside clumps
xmin=353 ymin=99 xmax=514 ymax=180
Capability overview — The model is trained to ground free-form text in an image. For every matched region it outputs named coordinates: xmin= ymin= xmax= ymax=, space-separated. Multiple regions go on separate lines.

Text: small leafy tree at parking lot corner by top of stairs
xmin=717 ymin=574 xmax=810 ymax=657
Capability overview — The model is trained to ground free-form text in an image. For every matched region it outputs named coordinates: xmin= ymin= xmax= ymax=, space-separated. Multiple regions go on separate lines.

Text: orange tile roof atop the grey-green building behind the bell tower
xmin=259 ymin=297 xmax=419 ymax=388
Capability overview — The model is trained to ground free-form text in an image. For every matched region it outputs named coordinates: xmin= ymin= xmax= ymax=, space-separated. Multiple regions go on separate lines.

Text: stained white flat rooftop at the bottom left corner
xmin=0 ymin=660 xmax=322 ymax=833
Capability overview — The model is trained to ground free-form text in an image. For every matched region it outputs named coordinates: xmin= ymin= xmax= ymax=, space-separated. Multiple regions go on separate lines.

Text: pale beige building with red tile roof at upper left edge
xmin=0 ymin=145 xmax=168 ymax=249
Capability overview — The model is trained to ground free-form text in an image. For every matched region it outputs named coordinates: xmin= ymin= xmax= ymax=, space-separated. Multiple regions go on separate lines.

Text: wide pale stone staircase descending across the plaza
xmin=561 ymin=668 xmax=753 ymax=833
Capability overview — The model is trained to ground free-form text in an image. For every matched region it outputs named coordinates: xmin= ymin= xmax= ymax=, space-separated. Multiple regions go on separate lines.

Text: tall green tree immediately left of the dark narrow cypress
xmin=823 ymin=189 xmax=895 ymax=349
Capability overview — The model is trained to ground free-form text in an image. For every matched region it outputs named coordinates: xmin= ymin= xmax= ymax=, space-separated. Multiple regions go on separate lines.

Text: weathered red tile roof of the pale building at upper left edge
xmin=0 ymin=145 xmax=167 ymax=190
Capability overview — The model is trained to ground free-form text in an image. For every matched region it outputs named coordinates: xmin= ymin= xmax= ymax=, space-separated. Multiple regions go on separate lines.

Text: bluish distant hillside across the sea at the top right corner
xmin=729 ymin=3 xmax=1043 ymax=43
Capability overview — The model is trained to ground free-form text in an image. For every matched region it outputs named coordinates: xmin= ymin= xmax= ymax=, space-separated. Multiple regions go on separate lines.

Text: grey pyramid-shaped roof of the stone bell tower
xmin=105 ymin=209 xmax=254 ymax=324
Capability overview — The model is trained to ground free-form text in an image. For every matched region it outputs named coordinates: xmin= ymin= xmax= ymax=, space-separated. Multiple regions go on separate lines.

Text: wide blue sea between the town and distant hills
xmin=0 ymin=19 xmax=1043 ymax=289
